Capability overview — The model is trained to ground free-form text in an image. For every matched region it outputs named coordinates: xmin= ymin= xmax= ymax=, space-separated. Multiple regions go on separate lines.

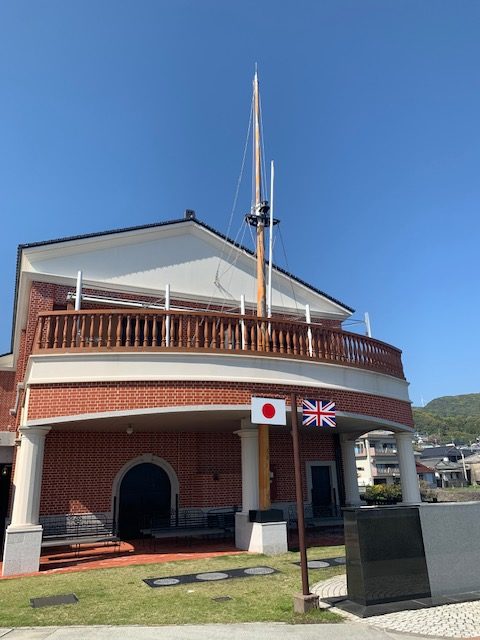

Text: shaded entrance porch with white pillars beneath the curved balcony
xmin=3 ymin=405 xmax=416 ymax=575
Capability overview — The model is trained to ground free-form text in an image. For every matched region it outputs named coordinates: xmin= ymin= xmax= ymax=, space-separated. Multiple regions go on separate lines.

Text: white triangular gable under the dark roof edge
xmin=22 ymin=221 xmax=350 ymax=320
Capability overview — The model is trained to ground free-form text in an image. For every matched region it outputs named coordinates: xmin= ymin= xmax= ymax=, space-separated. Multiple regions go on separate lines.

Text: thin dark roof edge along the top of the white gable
xmin=5 ymin=218 xmax=354 ymax=355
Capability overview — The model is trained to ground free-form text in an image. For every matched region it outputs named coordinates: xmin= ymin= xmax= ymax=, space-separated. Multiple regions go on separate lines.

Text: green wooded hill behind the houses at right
xmin=413 ymin=393 xmax=480 ymax=442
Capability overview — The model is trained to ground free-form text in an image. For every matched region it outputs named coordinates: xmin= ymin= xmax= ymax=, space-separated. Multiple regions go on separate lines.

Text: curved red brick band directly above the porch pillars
xmin=28 ymin=382 xmax=413 ymax=426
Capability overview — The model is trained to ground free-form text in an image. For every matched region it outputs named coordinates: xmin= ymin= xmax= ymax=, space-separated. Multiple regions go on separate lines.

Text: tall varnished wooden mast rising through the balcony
xmin=251 ymin=70 xmax=271 ymax=510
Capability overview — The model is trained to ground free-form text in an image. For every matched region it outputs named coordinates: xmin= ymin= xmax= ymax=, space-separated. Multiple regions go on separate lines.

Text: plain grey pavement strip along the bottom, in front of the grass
xmin=0 ymin=623 xmax=446 ymax=640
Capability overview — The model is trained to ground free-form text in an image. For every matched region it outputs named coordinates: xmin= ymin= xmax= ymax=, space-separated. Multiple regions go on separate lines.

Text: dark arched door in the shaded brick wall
xmin=118 ymin=462 xmax=172 ymax=540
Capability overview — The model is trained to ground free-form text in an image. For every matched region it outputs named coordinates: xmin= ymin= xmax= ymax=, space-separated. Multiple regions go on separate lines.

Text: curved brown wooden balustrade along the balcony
xmin=33 ymin=309 xmax=404 ymax=378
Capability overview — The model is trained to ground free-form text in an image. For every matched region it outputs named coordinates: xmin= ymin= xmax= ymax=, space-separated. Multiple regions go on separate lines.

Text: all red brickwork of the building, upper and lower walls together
xmin=0 ymin=282 xmax=413 ymax=515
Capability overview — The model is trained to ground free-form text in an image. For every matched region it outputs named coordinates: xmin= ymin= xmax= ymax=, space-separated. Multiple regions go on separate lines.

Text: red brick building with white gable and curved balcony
xmin=0 ymin=219 xmax=418 ymax=574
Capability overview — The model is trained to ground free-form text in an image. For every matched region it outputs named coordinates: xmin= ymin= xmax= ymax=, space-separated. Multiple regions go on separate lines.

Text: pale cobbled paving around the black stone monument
xmin=312 ymin=575 xmax=480 ymax=638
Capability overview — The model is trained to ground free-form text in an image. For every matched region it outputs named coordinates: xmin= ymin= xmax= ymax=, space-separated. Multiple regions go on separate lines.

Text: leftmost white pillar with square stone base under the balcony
xmin=3 ymin=426 xmax=50 ymax=576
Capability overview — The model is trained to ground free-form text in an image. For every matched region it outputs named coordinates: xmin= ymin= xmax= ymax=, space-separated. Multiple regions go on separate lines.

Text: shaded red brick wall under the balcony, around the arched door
xmin=40 ymin=428 xmax=335 ymax=515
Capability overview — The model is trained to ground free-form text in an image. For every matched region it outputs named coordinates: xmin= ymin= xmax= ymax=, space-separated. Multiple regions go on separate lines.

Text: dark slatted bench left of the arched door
xmin=40 ymin=513 xmax=120 ymax=553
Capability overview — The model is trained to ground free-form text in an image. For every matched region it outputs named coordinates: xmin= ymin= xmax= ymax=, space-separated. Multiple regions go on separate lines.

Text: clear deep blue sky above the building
xmin=0 ymin=0 xmax=480 ymax=404
